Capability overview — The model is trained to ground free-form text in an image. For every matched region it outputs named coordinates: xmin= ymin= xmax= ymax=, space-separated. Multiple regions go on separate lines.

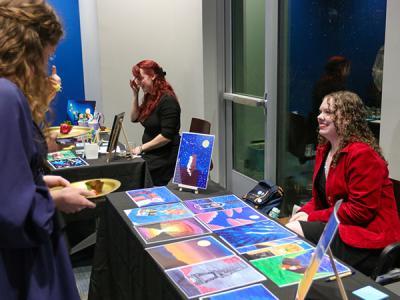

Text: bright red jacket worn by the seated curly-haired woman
xmin=301 ymin=142 xmax=400 ymax=249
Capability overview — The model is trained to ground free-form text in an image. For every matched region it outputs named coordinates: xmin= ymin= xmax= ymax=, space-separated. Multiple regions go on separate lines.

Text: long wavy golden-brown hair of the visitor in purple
xmin=0 ymin=0 xmax=63 ymax=123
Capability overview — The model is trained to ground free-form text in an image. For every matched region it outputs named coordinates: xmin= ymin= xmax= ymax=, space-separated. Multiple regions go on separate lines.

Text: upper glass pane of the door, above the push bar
xmin=232 ymin=0 xmax=265 ymax=97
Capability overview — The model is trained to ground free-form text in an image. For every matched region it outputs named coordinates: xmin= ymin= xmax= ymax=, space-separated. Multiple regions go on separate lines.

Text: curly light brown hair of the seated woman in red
xmin=318 ymin=91 xmax=384 ymax=165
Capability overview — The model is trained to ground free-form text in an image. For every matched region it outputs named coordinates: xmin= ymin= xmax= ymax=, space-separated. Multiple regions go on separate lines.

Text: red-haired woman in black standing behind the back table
xmin=130 ymin=60 xmax=181 ymax=185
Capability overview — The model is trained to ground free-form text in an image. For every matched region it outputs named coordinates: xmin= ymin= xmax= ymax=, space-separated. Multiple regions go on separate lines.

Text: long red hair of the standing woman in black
xmin=132 ymin=59 xmax=178 ymax=122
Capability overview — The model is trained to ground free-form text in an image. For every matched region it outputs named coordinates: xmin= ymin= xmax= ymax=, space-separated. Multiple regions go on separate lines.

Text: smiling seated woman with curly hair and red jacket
xmin=287 ymin=91 xmax=400 ymax=275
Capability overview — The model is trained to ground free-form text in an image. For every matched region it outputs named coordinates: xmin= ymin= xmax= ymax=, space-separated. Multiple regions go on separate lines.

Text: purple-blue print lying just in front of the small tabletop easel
xmin=184 ymin=195 xmax=246 ymax=214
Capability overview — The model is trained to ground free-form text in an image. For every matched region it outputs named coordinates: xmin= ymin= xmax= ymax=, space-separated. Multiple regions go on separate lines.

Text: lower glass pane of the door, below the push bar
xmin=232 ymin=103 xmax=264 ymax=180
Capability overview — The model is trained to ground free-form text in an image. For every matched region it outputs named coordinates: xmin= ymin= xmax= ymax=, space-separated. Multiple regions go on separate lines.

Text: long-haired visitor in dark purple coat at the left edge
xmin=0 ymin=0 xmax=95 ymax=300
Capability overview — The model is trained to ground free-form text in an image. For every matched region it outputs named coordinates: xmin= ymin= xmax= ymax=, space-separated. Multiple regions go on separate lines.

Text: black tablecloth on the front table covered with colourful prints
xmin=89 ymin=183 xmax=396 ymax=300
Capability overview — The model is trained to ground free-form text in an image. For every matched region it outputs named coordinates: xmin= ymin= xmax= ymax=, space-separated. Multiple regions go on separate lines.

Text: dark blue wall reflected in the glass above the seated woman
xmin=288 ymin=0 xmax=386 ymax=115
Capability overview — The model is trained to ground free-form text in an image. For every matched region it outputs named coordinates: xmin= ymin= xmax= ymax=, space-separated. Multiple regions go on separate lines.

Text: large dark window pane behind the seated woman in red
xmin=277 ymin=0 xmax=386 ymax=213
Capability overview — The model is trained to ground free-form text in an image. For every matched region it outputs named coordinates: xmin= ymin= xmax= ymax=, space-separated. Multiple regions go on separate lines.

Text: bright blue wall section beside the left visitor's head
xmin=48 ymin=0 xmax=85 ymax=125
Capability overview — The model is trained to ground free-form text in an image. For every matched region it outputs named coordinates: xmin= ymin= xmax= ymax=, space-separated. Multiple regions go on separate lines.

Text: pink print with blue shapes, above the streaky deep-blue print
xmin=196 ymin=206 xmax=268 ymax=230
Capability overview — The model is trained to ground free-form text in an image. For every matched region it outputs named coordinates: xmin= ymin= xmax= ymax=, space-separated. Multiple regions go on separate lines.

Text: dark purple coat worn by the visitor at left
xmin=0 ymin=78 xmax=79 ymax=300
